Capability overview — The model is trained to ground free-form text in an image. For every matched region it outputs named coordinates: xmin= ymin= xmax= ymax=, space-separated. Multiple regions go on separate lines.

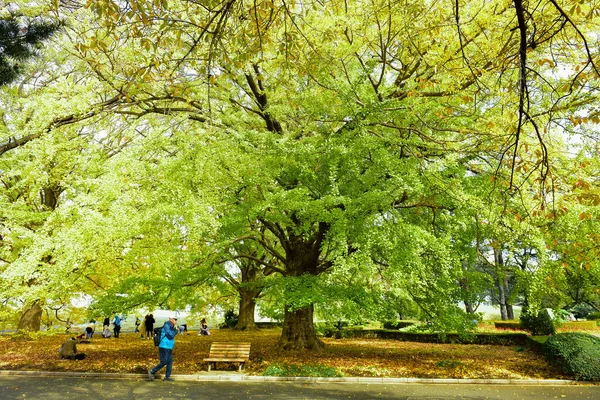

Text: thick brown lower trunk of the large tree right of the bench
xmin=279 ymin=305 xmax=324 ymax=350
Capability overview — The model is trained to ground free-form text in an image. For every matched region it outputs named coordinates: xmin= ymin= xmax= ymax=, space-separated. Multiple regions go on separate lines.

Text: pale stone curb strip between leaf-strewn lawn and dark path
xmin=0 ymin=370 xmax=594 ymax=386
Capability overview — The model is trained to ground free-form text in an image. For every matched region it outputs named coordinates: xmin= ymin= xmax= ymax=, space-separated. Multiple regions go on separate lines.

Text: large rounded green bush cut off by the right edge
xmin=543 ymin=332 xmax=600 ymax=381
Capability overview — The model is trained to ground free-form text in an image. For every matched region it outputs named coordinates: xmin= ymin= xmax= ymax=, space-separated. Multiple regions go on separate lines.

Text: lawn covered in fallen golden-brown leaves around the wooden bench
xmin=0 ymin=329 xmax=569 ymax=379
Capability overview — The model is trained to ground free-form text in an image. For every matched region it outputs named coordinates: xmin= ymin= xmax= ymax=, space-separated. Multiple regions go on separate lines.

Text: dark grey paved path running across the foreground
xmin=0 ymin=371 xmax=600 ymax=400
